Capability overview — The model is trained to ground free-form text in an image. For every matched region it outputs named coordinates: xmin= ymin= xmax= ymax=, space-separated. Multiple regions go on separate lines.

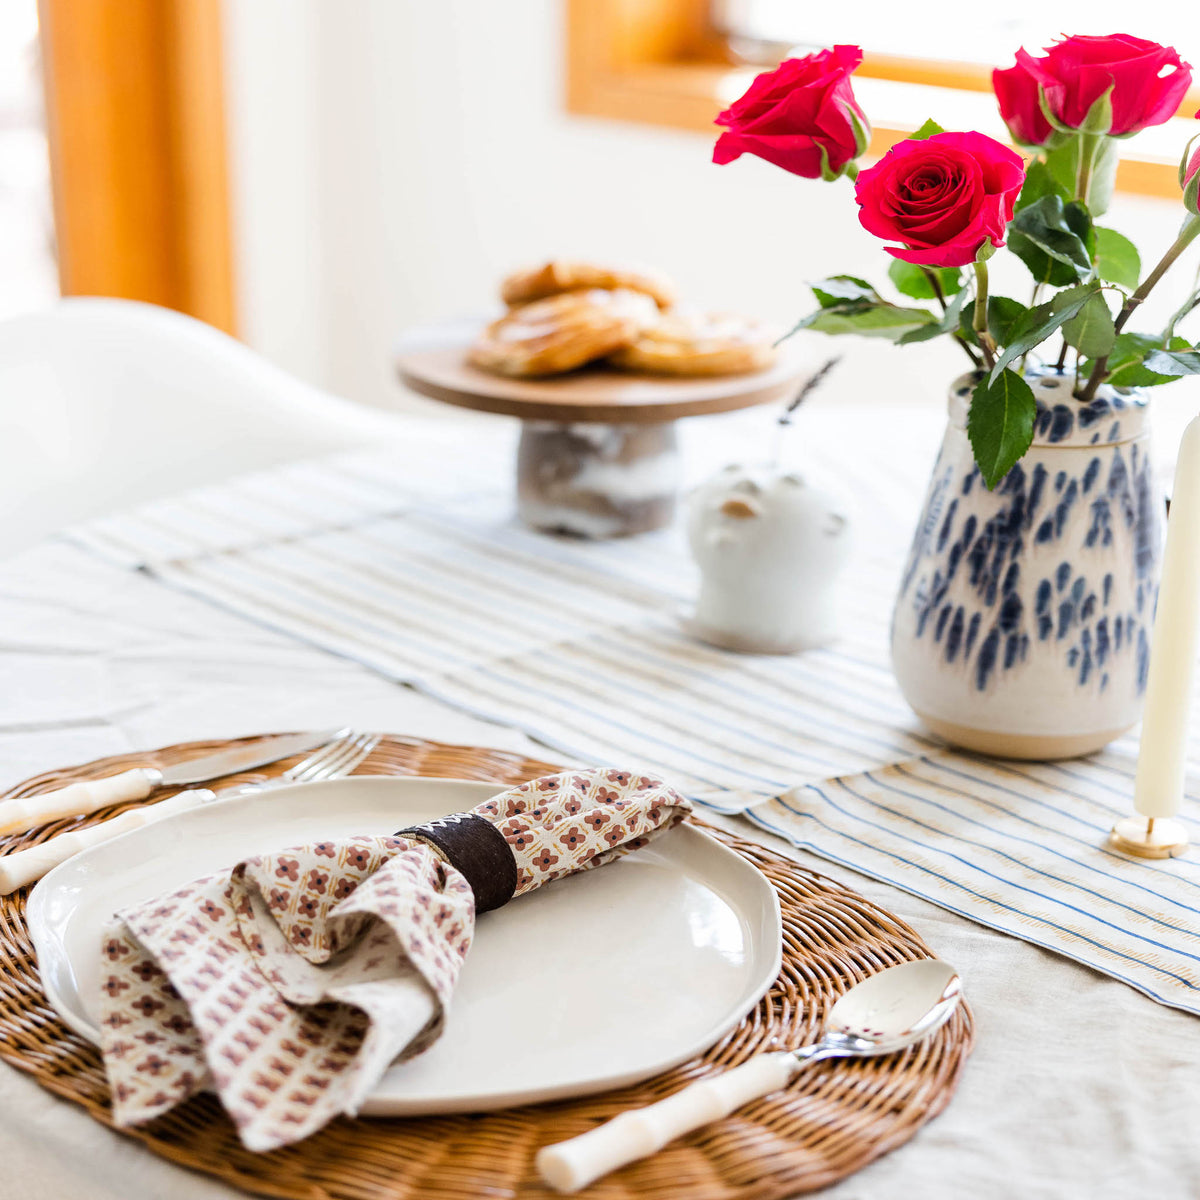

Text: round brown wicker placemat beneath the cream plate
xmin=0 ymin=737 xmax=973 ymax=1200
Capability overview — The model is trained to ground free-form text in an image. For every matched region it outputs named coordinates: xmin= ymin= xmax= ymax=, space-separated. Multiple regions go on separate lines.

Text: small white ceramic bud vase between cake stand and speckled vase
xmin=686 ymin=464 xmax=850 ymax=654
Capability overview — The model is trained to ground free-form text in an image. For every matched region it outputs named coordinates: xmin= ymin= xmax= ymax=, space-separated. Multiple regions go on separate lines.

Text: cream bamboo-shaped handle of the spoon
xmin=538 ymin=1050 xmax=797 ymax=1192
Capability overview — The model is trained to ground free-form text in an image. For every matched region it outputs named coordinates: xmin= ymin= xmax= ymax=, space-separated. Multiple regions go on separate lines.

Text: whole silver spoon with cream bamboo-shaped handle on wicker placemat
xmin=536 ymin=959 xmax=962 ymax=1192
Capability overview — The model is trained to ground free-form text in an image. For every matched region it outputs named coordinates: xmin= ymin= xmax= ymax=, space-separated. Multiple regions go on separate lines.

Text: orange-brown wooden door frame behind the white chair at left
xmin=38 ymin=0 xmax=235 ymax=332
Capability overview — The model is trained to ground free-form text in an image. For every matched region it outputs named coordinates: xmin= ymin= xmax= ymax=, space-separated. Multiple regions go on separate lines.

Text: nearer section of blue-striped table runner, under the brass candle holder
xmin=748 ymin=739 xmax=1200 ymax=1014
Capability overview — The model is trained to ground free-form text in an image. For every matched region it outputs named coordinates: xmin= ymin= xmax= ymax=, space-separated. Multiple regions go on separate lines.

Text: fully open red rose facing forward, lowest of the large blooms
xmin=854 ymin=133 xmax=1025 ymax=266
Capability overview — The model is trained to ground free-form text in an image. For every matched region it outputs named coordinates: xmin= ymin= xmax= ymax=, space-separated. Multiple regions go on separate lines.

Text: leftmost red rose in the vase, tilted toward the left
xmin=713 ymin=46 xmax=870 ymax=179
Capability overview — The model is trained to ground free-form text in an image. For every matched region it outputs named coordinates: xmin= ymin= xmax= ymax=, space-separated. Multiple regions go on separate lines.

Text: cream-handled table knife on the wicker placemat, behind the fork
xmin=0 ymin=730 xmax=343 ymax=835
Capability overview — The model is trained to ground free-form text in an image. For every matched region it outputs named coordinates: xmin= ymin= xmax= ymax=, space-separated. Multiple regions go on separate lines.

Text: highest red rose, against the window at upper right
xmin=992 ymin=34 xmax=1192 ymax=145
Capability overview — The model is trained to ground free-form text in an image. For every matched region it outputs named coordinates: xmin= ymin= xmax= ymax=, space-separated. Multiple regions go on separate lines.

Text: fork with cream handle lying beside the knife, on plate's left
xmin=0 ymin=730 xmax=382 ymax=895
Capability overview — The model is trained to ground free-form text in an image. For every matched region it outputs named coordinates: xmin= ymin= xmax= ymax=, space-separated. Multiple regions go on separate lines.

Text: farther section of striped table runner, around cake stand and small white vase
xmin=72 ymin=436 xmax=934 ymax=809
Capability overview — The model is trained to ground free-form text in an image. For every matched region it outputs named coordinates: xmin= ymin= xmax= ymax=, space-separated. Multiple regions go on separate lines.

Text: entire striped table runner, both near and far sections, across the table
xmin=63 ymin=429 xmax=1200 ymax=1012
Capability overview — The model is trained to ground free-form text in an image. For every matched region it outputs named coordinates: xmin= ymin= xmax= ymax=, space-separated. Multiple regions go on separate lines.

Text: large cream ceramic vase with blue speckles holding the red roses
xmin=892 ymin=373 xmax=1163 ymax=758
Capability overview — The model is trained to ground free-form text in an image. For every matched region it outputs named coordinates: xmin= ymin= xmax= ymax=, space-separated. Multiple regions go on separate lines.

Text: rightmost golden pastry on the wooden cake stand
xmin=608 ymin=313 xmax=775 ymax=376
